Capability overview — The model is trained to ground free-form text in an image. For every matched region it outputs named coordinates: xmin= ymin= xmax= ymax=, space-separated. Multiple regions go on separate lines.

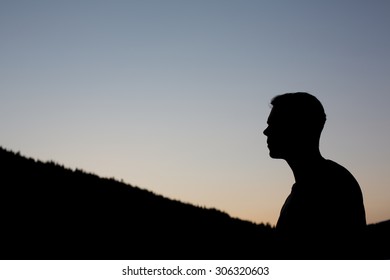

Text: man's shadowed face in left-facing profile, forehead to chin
xmin=263 ymin=107 xmax=300 ymax=159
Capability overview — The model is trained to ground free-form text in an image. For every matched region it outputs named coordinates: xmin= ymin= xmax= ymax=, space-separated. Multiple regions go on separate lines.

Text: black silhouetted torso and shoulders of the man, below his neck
xmin=276 ymin=160 xmax=366 ymax=256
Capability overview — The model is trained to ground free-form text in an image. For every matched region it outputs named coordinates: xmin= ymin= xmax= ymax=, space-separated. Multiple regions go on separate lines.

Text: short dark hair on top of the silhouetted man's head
xmin=271 ymin=92 xmax=326 ymax=133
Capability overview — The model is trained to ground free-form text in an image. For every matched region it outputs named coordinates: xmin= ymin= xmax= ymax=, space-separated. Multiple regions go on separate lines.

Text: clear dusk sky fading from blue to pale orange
xmin=0 ymin=0 xmax=390 ymax=224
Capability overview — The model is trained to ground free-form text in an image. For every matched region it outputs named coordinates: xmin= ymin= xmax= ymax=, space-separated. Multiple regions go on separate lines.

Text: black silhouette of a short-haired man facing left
xmin=264 ymin=92 xmax=366 ymax=258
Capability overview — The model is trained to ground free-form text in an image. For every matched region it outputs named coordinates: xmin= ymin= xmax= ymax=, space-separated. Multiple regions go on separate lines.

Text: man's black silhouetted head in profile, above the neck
xmin=264 ymin=92 xmax=326 ymax=160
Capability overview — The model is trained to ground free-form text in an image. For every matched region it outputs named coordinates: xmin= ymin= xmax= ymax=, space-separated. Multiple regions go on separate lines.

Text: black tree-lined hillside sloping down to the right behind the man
xmin=0 ymin=147 xmax=390 ymax=259
